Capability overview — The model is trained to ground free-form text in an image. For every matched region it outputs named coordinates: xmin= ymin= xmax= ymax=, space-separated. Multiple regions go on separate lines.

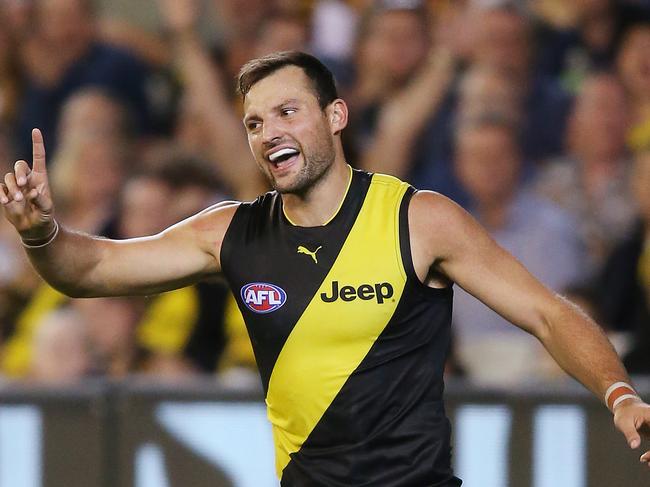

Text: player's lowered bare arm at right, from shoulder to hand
xmin=409 ymin=191 xmax=650 ymax=465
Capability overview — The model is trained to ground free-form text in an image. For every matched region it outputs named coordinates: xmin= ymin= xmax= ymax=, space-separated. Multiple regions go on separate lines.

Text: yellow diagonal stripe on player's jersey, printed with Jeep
xmin=266 ymin=174 xmax=408 ymax=477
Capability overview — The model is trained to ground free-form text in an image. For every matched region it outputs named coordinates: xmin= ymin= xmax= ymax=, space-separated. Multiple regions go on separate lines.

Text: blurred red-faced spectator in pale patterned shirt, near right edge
xmin=537 ymin=73 xmax=635 ymax=270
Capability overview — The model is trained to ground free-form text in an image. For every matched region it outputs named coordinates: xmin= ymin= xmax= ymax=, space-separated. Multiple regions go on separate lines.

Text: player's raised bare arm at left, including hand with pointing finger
xmin=0 ymin=129 xmax=238 ymax=297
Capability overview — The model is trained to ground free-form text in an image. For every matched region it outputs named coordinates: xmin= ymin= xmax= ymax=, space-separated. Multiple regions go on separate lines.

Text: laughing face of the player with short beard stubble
xmin=244 ymin=66 xmax=335 ymax=194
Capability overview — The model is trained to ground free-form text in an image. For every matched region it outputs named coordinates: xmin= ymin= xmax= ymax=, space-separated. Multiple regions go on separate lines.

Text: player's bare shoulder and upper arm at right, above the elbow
xmin=409 ymin=193 xmax=557 ymax=336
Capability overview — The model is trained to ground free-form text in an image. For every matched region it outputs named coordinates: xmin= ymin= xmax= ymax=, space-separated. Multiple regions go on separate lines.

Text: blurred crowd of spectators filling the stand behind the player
xmin=0 ymin=0 xmax=650 ymax=387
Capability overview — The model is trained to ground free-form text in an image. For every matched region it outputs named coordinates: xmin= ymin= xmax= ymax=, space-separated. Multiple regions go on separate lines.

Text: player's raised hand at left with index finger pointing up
xmin=0 ymin=129 xmax=54 ymax=242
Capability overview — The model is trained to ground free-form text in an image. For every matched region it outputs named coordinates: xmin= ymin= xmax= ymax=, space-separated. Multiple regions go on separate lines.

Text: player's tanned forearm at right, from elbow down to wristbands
xmin=538 ymin=296 xmax=630 ymax=408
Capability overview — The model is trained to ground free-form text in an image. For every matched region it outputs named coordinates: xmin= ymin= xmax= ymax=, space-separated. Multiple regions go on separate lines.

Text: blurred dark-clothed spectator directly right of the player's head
xmin=351 ymin=1 xmax=456 ymax=197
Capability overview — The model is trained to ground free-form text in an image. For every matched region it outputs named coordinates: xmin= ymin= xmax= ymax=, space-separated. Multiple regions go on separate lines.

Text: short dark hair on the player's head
xmin=237 ymin=51 xmax=339 ymax=108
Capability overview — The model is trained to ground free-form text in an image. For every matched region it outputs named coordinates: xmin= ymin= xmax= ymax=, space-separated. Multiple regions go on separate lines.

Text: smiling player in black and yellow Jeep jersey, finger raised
xmin=0 ymin=52 xmax=650 ymax=486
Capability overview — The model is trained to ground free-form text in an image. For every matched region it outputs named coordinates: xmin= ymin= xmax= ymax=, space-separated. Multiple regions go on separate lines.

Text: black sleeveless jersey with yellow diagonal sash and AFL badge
xmin=221 ymin=171 xmax=460 ymax=487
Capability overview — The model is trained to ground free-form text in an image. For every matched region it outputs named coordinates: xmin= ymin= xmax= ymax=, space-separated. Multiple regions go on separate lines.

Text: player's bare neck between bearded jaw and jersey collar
xmin=282 ymin=158 xmax=352 ymax=227
